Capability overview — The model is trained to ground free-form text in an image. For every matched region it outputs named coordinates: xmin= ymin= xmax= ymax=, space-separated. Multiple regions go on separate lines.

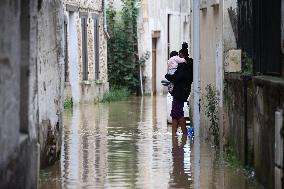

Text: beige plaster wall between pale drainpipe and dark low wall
xmin=200 ymin=0 xmax=223 ymax=132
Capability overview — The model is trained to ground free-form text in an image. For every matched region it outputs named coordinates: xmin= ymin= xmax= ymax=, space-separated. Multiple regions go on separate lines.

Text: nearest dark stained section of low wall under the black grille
xmin=253 ymin=76 xmax=284 ymax=188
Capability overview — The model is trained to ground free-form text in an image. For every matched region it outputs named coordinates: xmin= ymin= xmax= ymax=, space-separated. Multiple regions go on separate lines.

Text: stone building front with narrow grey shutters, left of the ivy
xmin=64 ymin=0 xmax=109 ymax=103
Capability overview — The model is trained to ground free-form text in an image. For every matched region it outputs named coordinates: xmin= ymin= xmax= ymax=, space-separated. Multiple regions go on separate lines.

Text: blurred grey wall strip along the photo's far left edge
xmin=0 ymin=0 xmax=21 ymax=168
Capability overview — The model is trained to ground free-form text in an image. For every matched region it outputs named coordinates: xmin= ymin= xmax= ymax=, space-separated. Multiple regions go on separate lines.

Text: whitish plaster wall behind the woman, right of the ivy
xmin=138 ymin=0 xmax=190 ymax=94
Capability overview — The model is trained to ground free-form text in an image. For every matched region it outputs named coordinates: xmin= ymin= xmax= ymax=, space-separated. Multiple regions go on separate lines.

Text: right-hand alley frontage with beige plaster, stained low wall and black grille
xmin=193 ymin=0 xmax=284 ymax=188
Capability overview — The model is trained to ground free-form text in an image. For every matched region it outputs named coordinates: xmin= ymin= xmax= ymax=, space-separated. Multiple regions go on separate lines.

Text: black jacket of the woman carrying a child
xmin=165 ymin=58 xmax=193 ymax=102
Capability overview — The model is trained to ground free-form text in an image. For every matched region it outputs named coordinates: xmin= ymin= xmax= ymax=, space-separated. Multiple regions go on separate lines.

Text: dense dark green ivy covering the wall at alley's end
xmin=107 ymin=0 xmax=139 ymax=93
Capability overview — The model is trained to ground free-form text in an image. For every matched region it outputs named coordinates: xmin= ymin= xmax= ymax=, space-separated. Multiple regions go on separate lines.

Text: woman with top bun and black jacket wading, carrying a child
xmin=165 ymin=43 xmax=193 ymax=134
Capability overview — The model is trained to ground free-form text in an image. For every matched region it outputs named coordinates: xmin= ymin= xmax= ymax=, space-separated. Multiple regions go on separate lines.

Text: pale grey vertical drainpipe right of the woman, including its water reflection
xmin=192 ymin=0 xmax=200 ymax=189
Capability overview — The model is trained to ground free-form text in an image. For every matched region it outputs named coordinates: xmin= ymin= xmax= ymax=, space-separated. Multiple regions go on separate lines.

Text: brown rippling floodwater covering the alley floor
xmin=39 ymin=96 xmax=259 ymax=189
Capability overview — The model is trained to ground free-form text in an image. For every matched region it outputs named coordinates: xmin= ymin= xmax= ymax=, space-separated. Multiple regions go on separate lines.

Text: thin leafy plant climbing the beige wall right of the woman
xmin=205 ymin=84 xmax=220 ymax=147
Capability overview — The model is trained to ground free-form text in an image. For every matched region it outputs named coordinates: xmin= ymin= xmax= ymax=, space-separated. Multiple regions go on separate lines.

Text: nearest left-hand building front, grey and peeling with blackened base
xmin=0 ymin=0 xmax=64 ymax=188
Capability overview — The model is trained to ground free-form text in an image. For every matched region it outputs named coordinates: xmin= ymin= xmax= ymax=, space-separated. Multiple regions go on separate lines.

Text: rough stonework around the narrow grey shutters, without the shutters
xmin=64 ymin=0 xmax=109 ymax=103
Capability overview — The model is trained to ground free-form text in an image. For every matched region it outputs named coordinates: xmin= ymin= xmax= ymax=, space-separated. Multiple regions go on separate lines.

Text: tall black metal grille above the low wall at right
xmin=237 ymin=0 xmax=281 ymax=75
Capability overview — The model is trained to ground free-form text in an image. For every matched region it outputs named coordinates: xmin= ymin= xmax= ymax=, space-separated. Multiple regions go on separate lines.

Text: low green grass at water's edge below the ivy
xmin=101 ymin=87 xmax=130 ymax=102
